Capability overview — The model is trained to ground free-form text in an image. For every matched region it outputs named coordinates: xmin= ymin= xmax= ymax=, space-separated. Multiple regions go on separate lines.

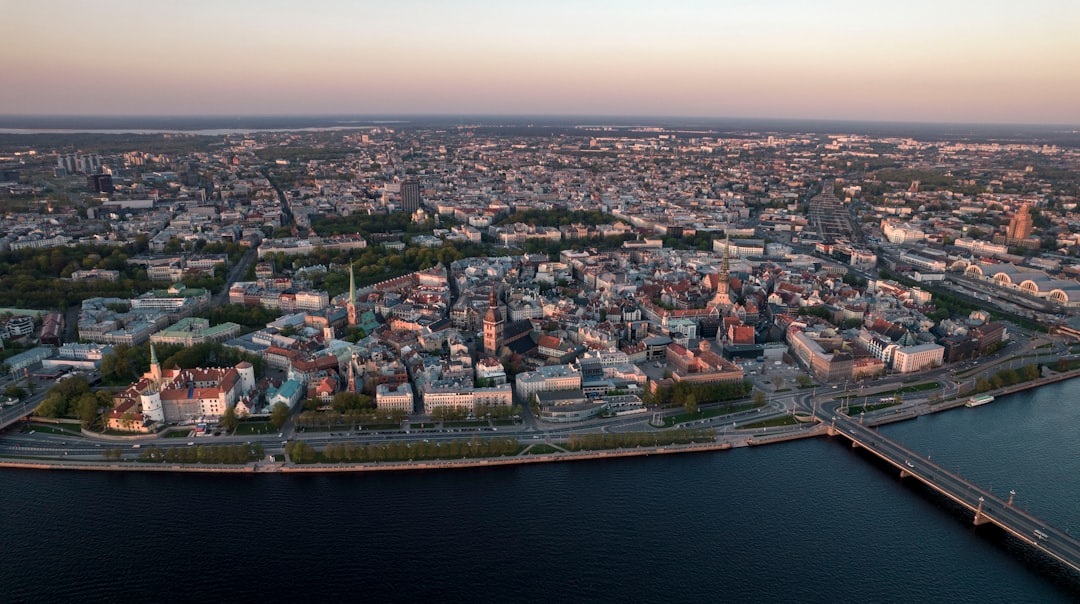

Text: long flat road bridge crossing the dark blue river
xmin=824 ymin=414 xmax=1080 ymax=572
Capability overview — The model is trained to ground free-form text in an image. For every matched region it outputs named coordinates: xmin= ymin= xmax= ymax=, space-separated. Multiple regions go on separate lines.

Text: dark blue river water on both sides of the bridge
xmin=0 ymin=380 xmax=1080 ymax=602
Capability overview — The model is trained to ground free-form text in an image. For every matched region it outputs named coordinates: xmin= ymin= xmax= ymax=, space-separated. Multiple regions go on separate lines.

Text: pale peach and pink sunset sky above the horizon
xmin=8 ymin=0 xmax=1080 ymax=124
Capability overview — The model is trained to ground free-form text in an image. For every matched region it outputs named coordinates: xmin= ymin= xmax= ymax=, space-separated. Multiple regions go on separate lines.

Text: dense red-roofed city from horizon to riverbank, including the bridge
xmin=0 ymin=122 xmax=1080 ymax=592
